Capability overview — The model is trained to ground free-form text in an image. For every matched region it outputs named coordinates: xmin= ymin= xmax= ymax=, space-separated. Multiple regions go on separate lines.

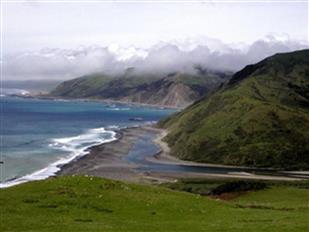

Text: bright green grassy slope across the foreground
xmin=0 ymin=176 xmax=309 ymax=232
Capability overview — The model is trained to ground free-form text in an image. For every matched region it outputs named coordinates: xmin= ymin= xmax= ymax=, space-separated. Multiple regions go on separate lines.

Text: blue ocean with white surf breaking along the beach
xmin=0 ymin=95 xmax=175 ymax=187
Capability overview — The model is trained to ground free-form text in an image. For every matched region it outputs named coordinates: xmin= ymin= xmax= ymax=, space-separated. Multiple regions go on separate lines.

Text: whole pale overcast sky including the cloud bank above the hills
xmin=2 ymin=0 xmax=308 ymax=79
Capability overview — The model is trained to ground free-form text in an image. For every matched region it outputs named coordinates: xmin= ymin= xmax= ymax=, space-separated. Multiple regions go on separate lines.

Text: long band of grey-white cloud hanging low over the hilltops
xmin=2 ymin=35 xmax=308 ymax=80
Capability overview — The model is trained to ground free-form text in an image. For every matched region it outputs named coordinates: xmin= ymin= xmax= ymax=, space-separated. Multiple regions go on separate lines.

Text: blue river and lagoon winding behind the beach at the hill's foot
xmin=123 ymin=133 xmax=309 ymax=179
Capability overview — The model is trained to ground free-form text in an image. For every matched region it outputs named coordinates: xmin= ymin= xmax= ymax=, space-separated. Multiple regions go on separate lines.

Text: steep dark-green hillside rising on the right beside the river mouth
xmin=159 ymin=50 xmax=309 ymax=169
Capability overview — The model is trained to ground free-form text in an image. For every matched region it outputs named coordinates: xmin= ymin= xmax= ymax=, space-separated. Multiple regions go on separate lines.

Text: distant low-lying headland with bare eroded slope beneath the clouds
xmin=50 ymin=69 xmax=230 ymax=107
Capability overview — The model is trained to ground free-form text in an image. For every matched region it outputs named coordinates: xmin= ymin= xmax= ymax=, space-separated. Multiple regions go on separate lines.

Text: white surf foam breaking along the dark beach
xmin=0 ymin=127 xmax=117 ymax=188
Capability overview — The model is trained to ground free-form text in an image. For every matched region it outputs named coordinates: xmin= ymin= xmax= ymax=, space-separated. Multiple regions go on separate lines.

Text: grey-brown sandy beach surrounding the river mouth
xmin=57 ymin=126 xmax=306 ymax=183
